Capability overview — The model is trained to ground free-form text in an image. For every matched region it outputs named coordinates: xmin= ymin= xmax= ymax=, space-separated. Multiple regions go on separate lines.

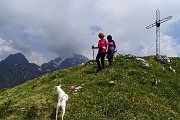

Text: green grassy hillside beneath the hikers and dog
xmin=0 ymin=55 xmax=180 ymax=120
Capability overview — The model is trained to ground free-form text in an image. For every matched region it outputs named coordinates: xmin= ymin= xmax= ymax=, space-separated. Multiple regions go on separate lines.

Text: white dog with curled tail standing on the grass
xmin=55 ymin=85 xmax=68 ymax=120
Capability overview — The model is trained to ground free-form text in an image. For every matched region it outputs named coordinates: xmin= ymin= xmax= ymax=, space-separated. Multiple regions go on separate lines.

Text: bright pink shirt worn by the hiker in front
xmin=98 ymin=39 xmax=108 ymax=52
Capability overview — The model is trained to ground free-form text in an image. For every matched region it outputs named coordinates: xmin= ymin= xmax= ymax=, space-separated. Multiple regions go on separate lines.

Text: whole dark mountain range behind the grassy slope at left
xmin=0 ymin=53 xmax=88 ymax=90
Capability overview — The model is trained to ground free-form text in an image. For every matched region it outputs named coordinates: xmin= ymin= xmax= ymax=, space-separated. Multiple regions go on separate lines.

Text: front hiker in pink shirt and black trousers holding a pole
xmin=92 ymin=33 xmax=108 ymax=71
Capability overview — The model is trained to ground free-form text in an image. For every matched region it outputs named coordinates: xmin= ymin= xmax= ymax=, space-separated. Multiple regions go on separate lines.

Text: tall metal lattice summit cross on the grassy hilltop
xmin=146 ymin=9 xmax=172 ymax=56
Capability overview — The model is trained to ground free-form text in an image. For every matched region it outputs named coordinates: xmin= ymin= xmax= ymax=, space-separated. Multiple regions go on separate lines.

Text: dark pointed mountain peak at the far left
xmin=0 ymin=53 xmax=42 ymax=89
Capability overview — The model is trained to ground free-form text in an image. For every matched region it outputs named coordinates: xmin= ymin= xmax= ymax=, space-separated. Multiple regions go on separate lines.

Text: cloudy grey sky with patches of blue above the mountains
xmin=0 ymin=0 xmax=180 ymax=65
